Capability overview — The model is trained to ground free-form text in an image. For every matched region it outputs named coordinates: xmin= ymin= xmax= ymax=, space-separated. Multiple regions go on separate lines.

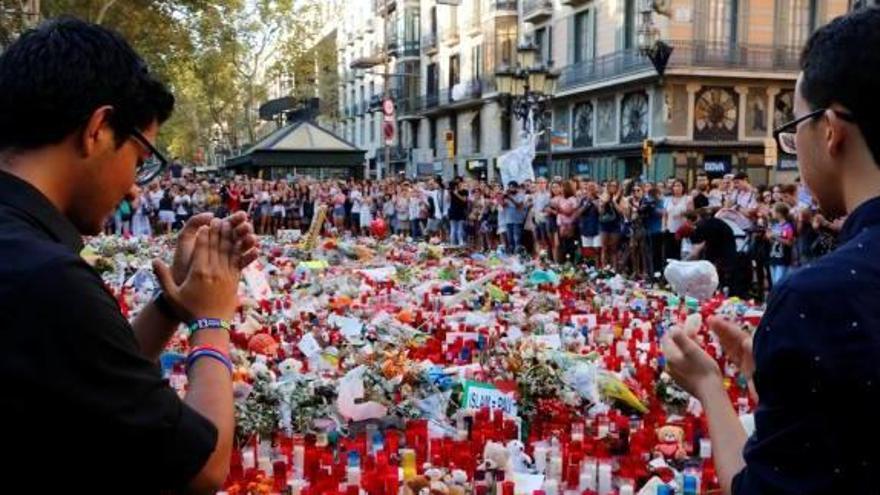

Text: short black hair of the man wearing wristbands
xmin=0 ymin=17 xmax=174 ymax=152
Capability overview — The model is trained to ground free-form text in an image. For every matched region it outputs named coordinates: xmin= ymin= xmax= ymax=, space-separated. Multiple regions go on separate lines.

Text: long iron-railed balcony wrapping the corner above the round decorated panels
xmin=558 ymin=41 xmax=800 ymax=91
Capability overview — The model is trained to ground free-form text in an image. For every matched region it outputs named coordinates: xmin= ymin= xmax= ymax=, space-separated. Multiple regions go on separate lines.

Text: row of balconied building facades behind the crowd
xmin=339 ymin=0 xmax=852 ymax=183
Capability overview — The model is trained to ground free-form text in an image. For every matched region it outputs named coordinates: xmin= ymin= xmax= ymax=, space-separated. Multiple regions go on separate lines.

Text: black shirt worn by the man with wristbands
xmin=0 ymin=172 xmax=217 ymax=494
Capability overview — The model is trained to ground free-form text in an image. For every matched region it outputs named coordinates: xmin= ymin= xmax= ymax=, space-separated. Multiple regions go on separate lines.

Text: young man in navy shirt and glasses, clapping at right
xmin=663 ymin=8 xmax=880 ymax=495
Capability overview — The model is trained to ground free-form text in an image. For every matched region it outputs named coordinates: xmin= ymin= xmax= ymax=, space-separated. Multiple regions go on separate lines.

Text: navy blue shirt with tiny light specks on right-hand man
xmin=733 ymin=198 xmax=880 ymax=495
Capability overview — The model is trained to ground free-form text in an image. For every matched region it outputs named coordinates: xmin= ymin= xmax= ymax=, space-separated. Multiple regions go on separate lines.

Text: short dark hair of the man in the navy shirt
xmin=801 ymin=7 xmax=880 ymax=164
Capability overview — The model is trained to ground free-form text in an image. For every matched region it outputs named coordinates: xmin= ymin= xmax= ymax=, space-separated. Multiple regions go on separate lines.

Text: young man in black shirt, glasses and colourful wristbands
xmin=0 ymin=19 xmax=256 ymax=493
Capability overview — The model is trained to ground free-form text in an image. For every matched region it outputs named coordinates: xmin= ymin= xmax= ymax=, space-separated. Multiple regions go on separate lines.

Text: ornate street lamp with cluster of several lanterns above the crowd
xmin=495 ymin=43 xmax=559 ymax=176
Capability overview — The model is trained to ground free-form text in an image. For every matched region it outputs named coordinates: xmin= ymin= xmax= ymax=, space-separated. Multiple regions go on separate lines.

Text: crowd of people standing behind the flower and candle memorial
xmin=107 ymin=173 xmax=843 ymax=300
